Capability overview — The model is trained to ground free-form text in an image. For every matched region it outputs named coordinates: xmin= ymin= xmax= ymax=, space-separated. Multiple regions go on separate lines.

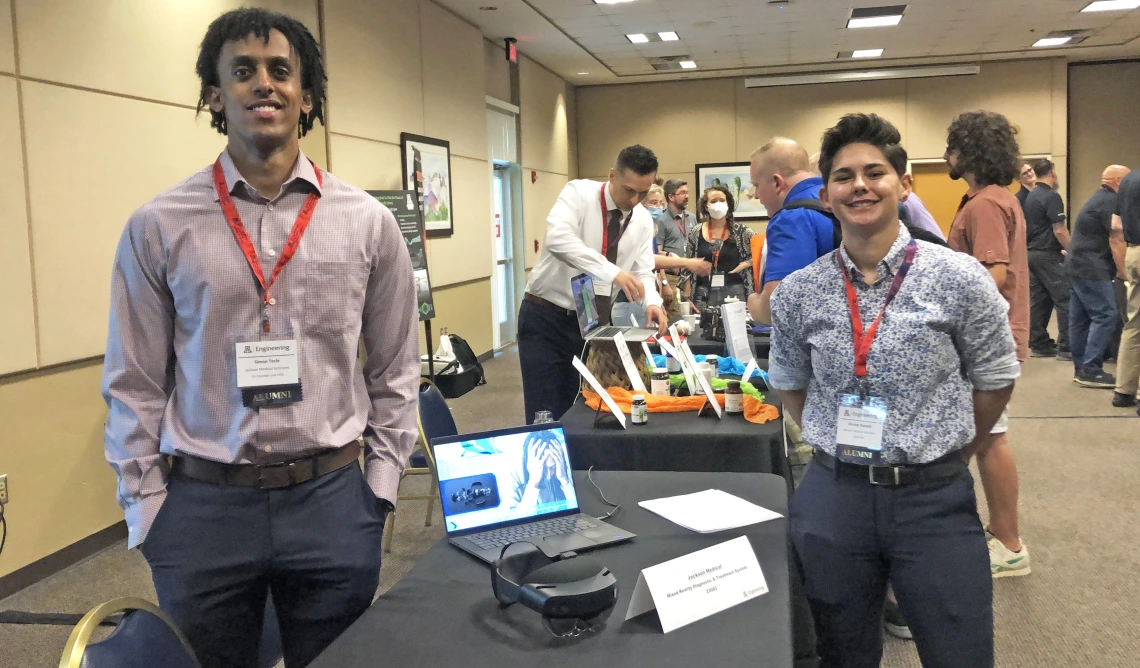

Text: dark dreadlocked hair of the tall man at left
xmin=195 ymin=7 xmax=328 ymax=137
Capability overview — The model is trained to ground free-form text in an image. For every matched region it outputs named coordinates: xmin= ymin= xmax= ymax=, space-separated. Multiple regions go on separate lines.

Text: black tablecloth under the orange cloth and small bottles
xmin=560 ymin=390 xmax=791 ymax=480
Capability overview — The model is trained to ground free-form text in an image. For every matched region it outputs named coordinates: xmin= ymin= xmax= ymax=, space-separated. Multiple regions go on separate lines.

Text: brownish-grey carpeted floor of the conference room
xmin=0 ymin=351 xmax=1140 ymax=668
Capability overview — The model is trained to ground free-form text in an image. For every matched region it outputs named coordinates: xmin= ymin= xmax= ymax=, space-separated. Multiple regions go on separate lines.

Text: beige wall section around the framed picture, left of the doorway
xmin=325 ymin=0 xmax=491 ymax=288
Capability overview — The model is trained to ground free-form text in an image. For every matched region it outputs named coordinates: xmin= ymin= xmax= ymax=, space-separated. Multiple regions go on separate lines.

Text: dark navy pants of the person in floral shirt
xmin=789 ymin=462 xmax=994 ymax=668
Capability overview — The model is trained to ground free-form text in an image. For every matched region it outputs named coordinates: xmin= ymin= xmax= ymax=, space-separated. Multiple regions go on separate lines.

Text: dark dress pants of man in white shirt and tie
xmin=519 ymin=301 xmax=585 ymax=424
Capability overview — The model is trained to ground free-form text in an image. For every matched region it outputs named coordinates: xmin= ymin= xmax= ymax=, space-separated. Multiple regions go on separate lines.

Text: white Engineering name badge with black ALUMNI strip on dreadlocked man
xmin=236 ymin=339 xmax=302 ymax=408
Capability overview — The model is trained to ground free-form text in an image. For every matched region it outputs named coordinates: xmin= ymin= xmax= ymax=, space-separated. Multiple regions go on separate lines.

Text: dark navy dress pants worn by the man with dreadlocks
xmin=143 ymin=465 xmax=384 ymax=668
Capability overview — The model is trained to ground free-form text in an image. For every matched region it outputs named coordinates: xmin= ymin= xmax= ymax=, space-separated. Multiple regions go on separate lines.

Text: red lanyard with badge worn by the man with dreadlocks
xmin=213 ymin=158 xmax=324 ymax=408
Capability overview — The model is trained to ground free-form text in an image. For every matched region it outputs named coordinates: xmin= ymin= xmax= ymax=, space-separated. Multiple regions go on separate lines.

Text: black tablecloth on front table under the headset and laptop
xmin=310 ymin=471 xmax=792 ymax=668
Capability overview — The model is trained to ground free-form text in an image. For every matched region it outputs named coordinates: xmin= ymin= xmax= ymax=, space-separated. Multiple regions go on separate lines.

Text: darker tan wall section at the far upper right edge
xmin=1062 ymin=63 xmax=1140 ymax=211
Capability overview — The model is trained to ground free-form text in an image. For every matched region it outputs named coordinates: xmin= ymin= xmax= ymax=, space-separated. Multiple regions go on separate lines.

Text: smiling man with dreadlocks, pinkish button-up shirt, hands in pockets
xmin=103 ymin=9 xmax=420 ymax=668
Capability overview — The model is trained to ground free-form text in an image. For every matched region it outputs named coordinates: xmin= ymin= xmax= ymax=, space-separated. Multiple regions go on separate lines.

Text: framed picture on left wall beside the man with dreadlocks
xmin=400 ymin=132 xmax=455 ymax=238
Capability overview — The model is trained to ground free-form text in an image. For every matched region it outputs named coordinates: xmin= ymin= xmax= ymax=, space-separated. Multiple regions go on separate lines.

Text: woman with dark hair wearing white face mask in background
xmin=681 ymin=186 xmax=752 ymax=309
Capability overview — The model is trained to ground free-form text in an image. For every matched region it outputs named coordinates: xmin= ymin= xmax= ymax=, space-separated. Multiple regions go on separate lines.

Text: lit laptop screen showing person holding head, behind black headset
xmin=432 ymin=424 xmax=578 ymax=533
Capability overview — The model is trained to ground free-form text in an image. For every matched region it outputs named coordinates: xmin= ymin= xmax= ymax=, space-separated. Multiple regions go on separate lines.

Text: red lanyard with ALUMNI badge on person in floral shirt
xmin=836 ymin=239 xmax=918 ymax=466
